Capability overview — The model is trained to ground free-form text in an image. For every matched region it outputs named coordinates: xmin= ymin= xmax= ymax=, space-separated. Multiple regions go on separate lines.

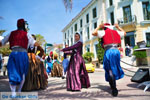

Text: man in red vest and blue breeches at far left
xmin=0 ymin=19 xmax=37 ymax=96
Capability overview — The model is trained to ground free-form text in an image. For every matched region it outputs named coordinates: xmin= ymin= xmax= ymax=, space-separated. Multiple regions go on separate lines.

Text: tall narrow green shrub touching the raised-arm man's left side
xmin=97 ymin=39 xmax=105 ymax=63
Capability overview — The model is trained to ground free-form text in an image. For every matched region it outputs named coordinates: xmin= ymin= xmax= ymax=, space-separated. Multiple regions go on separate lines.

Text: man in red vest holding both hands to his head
xmin=92 ymin=23 xmax=126 ymax=96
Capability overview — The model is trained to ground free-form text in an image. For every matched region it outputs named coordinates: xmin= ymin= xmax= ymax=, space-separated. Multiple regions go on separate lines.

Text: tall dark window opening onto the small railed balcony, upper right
xmin=123 ymin=6 xmax=132 ymax=23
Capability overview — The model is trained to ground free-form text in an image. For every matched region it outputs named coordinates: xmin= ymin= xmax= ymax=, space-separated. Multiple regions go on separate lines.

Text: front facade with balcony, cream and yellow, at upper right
xmin=105 ymin=0 xmax=150 ymax=48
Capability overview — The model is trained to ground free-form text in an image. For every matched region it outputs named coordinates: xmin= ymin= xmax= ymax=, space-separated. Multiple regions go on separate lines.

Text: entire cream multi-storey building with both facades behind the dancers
xmin=62 ymin=0 xmax=150 ymax=66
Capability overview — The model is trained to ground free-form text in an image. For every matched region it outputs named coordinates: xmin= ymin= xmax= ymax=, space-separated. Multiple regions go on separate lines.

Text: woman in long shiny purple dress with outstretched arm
xmin=62 ymin=33 xmax=90 ymax=91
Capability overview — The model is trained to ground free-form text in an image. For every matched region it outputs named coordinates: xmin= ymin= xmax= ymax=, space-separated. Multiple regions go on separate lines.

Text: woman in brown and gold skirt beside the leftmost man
xmin=22 ymin=34 xmax=47 ymax=91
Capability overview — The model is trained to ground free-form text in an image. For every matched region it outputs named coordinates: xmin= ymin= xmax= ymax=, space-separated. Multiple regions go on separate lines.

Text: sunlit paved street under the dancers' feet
xmin=0 ymin=68 xmax=150 ymax=100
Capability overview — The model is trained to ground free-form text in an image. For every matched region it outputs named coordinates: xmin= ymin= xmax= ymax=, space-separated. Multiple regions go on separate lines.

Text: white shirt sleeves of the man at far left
xmin=1 ymin=33 xmax=36 ymax=47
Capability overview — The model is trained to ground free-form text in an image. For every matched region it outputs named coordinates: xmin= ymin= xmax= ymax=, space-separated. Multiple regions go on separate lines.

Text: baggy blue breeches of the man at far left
xmin=7 ymin=52 xmax=29 ymax=85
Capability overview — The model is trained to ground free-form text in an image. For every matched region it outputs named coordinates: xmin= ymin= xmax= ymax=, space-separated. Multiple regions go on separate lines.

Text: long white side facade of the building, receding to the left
xmin=62 ymin=0 xmax=105 ymax=67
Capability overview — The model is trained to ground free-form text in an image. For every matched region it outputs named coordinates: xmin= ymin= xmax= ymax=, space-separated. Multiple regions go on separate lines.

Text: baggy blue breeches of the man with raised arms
xmin=103 ymin=49 xmax=124 ymax=81
